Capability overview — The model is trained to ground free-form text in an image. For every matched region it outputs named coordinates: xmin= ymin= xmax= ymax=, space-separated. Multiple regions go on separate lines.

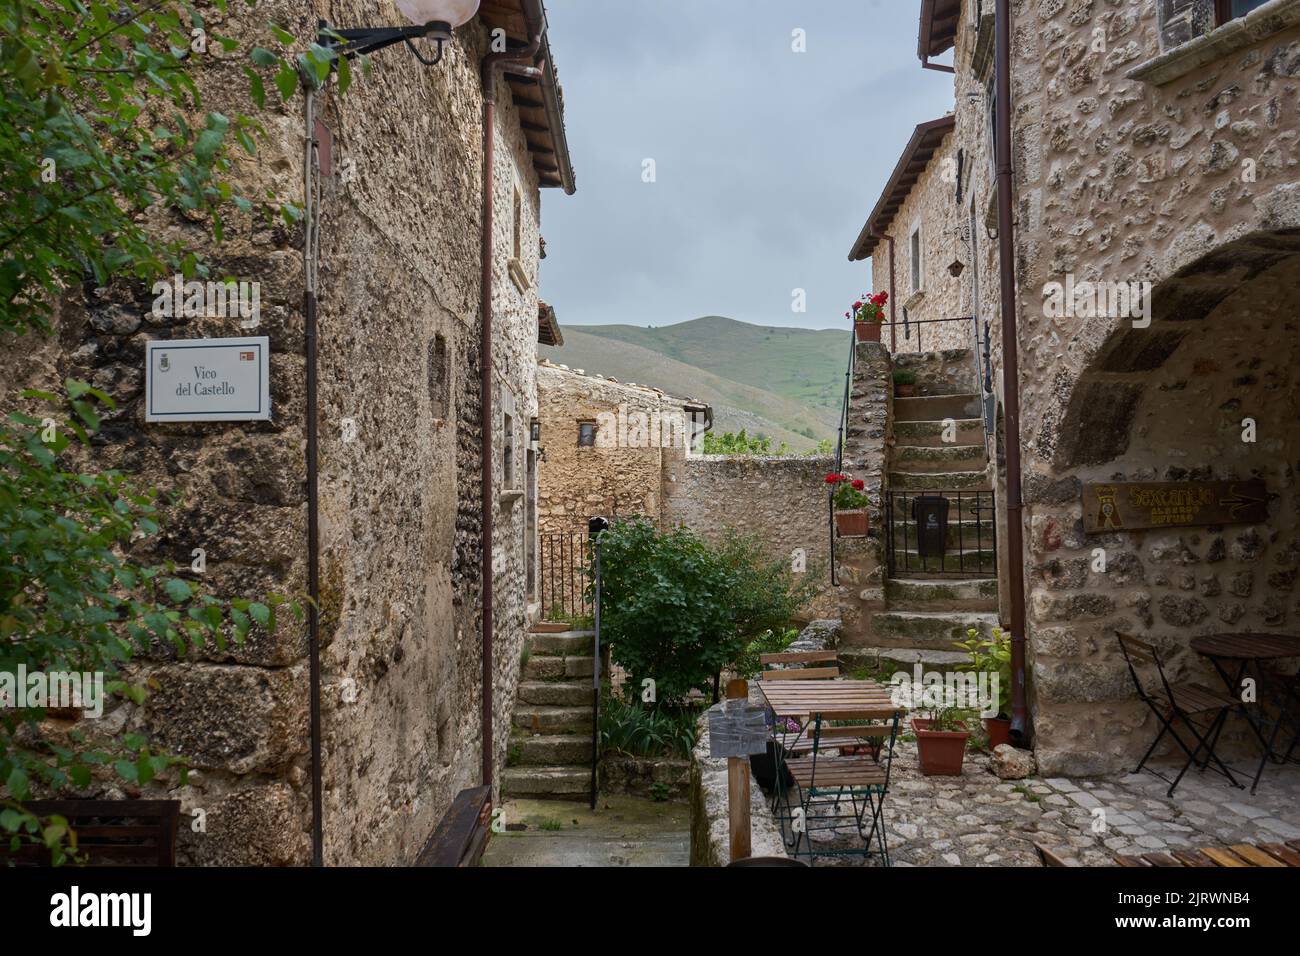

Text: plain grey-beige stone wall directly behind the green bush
xmin=664 ymin=455 xmax=836 ymax=620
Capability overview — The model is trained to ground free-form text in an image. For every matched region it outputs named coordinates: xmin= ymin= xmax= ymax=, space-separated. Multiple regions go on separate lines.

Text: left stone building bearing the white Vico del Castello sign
xmin=3 ymin=0 xmax=573 ymax=865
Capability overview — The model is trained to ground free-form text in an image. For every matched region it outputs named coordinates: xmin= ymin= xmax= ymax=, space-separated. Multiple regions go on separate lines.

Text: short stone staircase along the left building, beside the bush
xmin=502 ymin=631 xmax=595 ymax=800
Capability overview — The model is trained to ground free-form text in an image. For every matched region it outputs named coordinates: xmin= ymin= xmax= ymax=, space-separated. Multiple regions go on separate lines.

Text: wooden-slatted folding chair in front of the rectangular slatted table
xmin=777 ymin=710 xmax=898 ymax=866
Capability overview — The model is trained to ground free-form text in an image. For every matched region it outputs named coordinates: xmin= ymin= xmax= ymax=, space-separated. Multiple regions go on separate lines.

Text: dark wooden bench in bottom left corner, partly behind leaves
xmin=0 ymin=800 xmax=181 ymax=866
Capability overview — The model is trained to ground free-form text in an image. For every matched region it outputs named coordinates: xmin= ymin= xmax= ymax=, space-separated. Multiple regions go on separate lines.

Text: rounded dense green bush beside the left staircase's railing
xmin=593 ymin=518 xmax=816 ymax=705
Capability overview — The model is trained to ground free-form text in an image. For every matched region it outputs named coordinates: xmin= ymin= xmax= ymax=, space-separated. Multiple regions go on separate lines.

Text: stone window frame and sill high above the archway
xmin=1125 ymin=0 xmax=1300 ymax=86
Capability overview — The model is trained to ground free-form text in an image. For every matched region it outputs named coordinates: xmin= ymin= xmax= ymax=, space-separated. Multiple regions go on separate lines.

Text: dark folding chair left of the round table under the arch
xmin=1115 ymin=631 xmax=1243 ymax=796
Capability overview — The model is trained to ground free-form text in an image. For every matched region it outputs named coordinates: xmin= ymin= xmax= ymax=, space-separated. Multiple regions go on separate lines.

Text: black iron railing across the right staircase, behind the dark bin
xmin=884 ymin=490 xmax=997 ymax=578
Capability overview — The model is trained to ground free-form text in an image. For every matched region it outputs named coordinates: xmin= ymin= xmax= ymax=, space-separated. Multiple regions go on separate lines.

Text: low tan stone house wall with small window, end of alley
xmin=537 ymin=363 xmax=690 ymax=535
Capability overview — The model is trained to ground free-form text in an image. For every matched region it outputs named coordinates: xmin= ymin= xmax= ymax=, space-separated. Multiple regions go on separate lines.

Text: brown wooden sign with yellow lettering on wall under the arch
xmin=1083 ymin=479 xmax=1269 ymax=535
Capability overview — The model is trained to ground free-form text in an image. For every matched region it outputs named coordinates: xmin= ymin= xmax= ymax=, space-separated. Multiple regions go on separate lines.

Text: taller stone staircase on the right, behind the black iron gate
xmin=841 ymin=350 xmax=998 ymax=672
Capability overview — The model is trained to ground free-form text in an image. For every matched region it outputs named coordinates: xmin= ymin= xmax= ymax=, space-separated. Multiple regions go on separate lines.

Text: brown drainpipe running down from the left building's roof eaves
xmin=478 ymin=31 xmax=542 ymax=787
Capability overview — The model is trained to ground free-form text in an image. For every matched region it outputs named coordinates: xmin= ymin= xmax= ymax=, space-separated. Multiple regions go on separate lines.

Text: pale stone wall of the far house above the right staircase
xmin=871 ymin=126 xmax=971 ymax=352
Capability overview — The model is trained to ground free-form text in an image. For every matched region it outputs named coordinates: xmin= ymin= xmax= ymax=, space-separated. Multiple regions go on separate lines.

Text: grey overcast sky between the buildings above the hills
xmin=541 ymin=0 xmax=953 ymax=329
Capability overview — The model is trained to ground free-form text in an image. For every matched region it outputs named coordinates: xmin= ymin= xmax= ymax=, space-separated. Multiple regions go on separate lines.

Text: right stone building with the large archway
xmin=837 ymin=0 xmax=1300 ymax=774
